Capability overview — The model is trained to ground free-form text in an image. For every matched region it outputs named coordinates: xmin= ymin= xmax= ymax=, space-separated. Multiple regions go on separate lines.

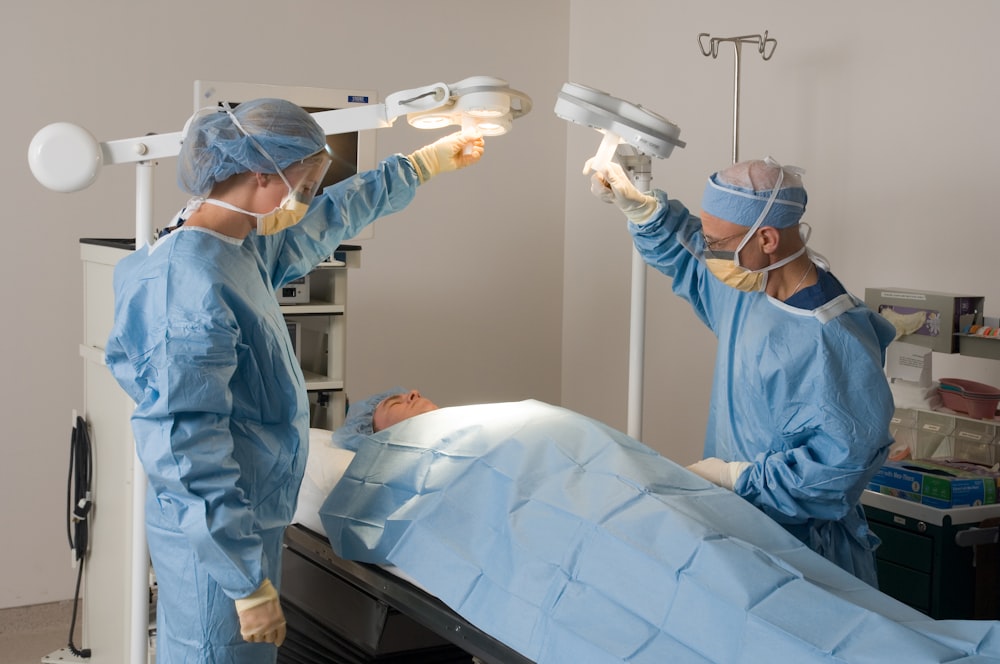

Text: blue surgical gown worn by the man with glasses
xmin=629 ymin=191 xmax=895 ymax=586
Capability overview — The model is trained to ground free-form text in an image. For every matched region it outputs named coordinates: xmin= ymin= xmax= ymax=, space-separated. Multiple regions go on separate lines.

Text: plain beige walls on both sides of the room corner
xmin=0 ymin=0 xmax=1000 ymax=607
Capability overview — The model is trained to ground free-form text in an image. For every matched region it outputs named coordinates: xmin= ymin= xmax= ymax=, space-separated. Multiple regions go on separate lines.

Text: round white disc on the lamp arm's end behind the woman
xmin=28 ymin=122 xmax=104 ymax=192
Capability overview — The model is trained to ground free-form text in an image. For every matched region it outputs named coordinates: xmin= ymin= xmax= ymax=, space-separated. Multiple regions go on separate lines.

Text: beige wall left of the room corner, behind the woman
xmin=0 ymin=0 xmax=569 ymax=608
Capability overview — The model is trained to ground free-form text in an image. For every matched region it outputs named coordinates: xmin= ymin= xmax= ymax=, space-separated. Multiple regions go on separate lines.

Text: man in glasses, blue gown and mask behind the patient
xmin=585 ymin=158 xmax=895 ymax=587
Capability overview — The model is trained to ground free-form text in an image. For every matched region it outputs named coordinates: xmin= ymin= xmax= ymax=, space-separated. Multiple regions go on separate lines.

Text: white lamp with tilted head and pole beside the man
xmin=555 ymin=83 xmax=686 ymax=440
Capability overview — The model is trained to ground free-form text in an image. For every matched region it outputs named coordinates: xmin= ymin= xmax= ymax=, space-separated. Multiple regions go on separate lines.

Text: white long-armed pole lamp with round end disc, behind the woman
xmin=28 ymin=76 xmax=531 ymax=662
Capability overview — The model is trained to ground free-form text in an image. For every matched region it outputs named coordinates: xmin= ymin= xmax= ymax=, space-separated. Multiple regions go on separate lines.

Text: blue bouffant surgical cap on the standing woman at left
xmin=177 ymin=99 xmax=326 ymax=196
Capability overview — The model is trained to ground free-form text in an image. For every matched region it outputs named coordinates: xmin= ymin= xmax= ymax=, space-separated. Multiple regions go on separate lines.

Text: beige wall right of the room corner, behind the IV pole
xmin=562 ymin=0 xmax=1000 ymax=463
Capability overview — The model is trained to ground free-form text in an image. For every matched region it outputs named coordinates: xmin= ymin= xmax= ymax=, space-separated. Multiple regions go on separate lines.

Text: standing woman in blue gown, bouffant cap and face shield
xmin=106 ymin=99 xmax=483 ymax=664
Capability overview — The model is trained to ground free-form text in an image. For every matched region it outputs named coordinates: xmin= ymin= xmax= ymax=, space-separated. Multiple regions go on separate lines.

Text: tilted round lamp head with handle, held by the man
xmin=555 ymin=83 xmax=686 ymax=178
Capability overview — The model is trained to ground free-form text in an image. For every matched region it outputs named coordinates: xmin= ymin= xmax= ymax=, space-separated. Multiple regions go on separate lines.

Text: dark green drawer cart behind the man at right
xmin=861 ymin=491 xmax=1000 ymax=619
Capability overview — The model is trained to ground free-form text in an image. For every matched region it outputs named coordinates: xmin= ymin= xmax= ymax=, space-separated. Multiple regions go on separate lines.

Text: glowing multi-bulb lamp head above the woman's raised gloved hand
xmin=406 ymin=76 xmax=531 ymax=136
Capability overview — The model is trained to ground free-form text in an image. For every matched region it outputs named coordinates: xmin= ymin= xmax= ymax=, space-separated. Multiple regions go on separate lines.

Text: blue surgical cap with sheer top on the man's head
xmin=701 ymin=158 xmax=806 ymax=228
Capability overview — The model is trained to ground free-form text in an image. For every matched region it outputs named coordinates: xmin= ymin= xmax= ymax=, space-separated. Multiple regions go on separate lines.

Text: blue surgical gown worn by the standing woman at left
xmin=106 ymin=155 xmax=418 ymax=664
